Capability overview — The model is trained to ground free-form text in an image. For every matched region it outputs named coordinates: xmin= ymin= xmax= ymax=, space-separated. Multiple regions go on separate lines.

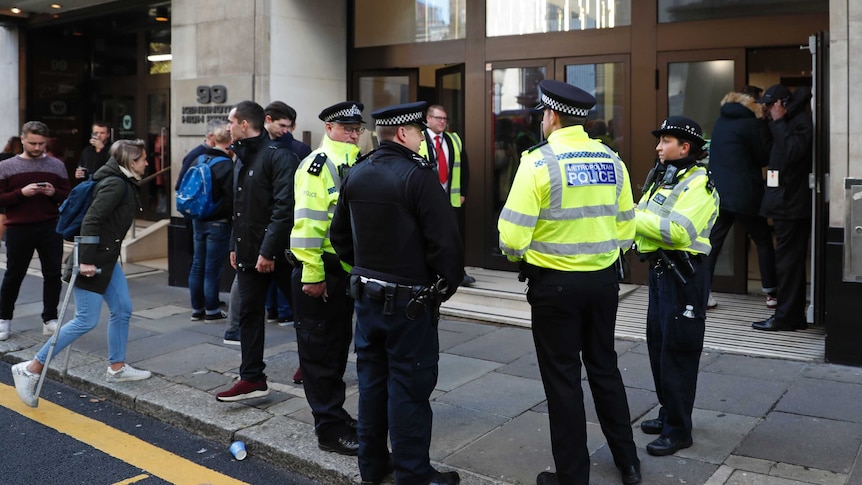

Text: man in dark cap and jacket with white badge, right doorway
xmin=751 ymin=84 xmax=814 ymax=330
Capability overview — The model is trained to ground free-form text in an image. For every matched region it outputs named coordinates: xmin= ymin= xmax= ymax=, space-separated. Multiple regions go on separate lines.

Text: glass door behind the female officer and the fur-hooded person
xmin=655 ymin=49 xmax=748 ymax=293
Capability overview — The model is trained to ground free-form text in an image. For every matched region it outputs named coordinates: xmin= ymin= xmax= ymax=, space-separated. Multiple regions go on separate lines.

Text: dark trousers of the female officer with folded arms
xmin=647 ymin=258 xmax=709 ymax=440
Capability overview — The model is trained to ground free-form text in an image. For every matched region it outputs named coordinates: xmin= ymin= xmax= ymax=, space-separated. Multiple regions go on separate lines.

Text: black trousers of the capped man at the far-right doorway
xmin=773 ymin=219 xmax=811 ymax=326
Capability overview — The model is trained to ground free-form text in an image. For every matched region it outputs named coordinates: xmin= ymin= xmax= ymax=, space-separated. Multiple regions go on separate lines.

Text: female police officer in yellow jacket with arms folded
xmin=635 ymin=116 xmax=718 ymax=456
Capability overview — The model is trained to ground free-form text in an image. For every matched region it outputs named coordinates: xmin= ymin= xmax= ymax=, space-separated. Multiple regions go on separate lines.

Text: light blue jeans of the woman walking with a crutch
xmin=36 ymin=262 xmax=132 ymax=364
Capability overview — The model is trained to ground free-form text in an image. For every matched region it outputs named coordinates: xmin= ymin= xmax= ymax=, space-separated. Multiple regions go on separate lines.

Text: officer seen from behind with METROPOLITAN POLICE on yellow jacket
xmin=497 ymin=80 xmax=641 ymax=485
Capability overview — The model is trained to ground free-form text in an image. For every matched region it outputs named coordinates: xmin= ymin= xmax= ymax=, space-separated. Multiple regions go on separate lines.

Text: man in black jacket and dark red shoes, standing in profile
xmin=216 ymin=101 xmax=299 ymax=402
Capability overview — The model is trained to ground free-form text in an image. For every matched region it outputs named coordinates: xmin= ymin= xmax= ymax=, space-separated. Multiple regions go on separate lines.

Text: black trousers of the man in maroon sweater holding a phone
xmin=0 ymin=220 xmax=63 ymax=322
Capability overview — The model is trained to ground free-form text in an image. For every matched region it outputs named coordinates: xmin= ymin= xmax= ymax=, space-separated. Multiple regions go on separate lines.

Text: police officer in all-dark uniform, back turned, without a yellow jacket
xmin=332 ymin=102 xmax=464 ymax=485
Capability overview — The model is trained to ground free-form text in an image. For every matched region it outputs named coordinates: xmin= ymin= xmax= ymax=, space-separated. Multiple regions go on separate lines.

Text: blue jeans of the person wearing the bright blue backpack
xmin=189 ymin=221 xmax=230 ymax=313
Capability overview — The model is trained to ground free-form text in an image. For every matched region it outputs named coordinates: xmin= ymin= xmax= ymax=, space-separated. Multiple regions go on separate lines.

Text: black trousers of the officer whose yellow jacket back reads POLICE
xmin=527 ymin=267 xmax=639 ymax=484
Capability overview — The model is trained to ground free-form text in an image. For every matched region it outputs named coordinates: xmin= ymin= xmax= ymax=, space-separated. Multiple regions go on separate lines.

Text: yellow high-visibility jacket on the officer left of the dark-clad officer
xmin=290 ymin=136 xmax=359 ymax=283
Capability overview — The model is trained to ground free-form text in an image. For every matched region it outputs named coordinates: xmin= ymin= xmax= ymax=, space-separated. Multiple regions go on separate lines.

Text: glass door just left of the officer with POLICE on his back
xmin=486 ymin=59 xmax=553 ymax=271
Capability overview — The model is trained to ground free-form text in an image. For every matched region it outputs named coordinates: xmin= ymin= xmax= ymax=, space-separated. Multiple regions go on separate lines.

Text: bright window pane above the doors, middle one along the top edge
xmin=486 ymin=0 xmax=631 ymax=37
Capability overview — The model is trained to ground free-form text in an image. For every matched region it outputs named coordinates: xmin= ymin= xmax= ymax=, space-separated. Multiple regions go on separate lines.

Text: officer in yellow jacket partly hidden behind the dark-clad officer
xmin=290 ymin=101 xmax=363 ymax=455
